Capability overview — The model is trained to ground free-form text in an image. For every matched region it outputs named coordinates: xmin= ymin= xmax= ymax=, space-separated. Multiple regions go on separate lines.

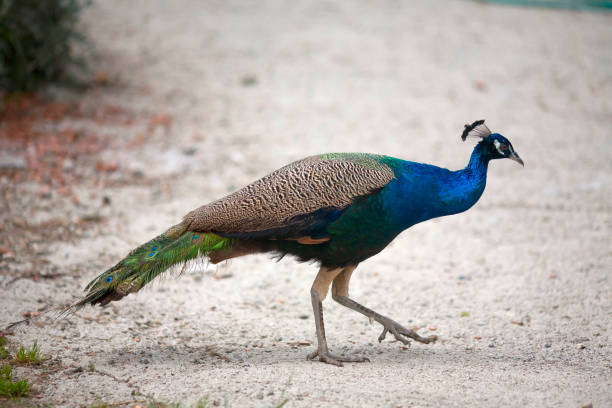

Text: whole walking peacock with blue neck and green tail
xmin=66 ymin=120 xmax=524 ymax=366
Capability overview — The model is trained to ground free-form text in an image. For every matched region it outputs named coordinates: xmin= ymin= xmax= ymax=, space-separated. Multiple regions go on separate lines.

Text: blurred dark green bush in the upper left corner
xmin=0 ymin=0 xmax=86 ymax=92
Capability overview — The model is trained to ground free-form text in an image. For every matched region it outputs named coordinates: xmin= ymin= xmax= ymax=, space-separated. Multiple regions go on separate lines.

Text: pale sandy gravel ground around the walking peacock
xmin=0 ymin=0 xmax=612 ymax=407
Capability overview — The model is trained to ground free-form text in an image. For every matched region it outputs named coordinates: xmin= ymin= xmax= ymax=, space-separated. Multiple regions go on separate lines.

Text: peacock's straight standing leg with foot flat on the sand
xmin=307 ymin=267 xmax=370 ymax=367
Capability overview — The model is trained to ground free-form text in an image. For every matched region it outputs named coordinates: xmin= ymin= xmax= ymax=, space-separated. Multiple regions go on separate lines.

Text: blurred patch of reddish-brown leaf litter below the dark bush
xmin=0 ymin=94 xmax=172 ymax=195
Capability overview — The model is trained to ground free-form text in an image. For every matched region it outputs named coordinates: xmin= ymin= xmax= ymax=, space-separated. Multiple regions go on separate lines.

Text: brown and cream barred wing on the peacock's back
xmin=184 ymin=153 xmax=394 ymax=234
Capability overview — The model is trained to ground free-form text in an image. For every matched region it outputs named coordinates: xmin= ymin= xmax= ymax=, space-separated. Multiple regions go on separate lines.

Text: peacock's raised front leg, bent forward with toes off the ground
xmin=332 ymin=267 xmax=437 ymax=344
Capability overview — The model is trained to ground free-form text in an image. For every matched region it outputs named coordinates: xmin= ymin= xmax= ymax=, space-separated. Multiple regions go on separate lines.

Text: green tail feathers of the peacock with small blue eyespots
xmin=66 ymin=223 xmax=235 ymax=312
